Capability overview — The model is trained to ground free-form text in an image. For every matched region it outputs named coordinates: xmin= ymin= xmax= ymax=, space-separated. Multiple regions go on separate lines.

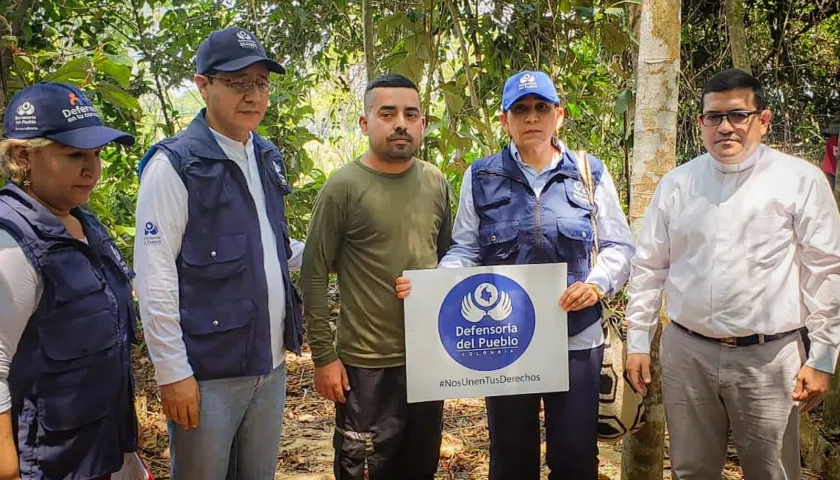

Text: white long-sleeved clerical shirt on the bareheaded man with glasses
xmin=626 ymin=145 xmax=840 ymax=372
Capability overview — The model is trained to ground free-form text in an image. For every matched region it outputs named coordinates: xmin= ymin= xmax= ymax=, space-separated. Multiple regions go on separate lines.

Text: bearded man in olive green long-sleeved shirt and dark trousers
xmin=300 ymin=75 xmax=452 ymax=480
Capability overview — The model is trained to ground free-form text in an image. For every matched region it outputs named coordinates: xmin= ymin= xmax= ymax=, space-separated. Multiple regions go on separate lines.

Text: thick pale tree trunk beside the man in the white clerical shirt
xmin=621 ymin=0 xmax=681 ymax=480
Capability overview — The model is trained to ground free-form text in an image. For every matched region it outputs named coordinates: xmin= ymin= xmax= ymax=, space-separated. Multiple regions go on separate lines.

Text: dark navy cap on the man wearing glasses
xmin=195 ymin=27 xmax=286 ymax=75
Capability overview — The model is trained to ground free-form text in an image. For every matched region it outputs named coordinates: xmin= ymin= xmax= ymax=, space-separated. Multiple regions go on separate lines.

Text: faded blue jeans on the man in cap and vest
xmin=169 ymin=364 xmax=286 ymax=480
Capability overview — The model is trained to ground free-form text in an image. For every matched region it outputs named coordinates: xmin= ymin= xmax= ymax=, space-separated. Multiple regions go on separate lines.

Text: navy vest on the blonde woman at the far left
xmin=0 ymin=184 xmax=137 ymax=480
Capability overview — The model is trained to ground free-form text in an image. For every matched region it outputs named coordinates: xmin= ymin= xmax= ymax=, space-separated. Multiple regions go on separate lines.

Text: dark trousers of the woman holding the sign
xmin=487 ymin=346 xmax=604 ymax=480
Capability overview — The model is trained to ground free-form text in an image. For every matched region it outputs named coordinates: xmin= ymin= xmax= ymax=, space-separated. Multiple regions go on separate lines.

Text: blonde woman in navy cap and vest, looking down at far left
xmin=0 ymin=83 xmax=138 ymax=480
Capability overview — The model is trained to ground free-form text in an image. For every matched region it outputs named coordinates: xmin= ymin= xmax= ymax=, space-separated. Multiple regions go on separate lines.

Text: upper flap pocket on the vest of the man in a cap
xmin=181 ymin=233 xmax=248 ymax=280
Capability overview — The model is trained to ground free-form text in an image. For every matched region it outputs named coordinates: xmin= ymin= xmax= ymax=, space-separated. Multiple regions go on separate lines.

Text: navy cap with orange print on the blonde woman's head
xmin=3 ymin=82 xmax=134 ymax=149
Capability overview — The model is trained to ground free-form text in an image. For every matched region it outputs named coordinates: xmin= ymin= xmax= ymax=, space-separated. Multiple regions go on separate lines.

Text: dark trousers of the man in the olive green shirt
xmin=333 ymin=366 xmax=443 ymax=480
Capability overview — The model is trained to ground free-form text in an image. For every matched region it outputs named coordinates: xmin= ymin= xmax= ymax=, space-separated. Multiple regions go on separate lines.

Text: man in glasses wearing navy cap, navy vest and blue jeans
xmin=134 ymin=27 xmax=303 ymax=480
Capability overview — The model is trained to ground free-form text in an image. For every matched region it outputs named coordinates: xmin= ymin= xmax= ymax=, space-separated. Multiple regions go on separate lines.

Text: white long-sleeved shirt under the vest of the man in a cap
xmin=134 ymin=129 xmax=303 ymax=385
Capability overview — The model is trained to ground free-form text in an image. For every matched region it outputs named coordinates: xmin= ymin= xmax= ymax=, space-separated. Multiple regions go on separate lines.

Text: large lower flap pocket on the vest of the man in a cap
xmin=181 ymin=300 xmax=255 ymax=379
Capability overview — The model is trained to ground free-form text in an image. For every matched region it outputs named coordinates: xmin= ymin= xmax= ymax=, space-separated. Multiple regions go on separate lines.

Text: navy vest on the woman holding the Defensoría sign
xmin=472 ymin=142 xmax=604 ymax=336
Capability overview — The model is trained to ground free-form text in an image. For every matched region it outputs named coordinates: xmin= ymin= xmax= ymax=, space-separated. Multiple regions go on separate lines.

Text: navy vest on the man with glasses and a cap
xmin=138 ymin=110 xmax=303 ymax=380
